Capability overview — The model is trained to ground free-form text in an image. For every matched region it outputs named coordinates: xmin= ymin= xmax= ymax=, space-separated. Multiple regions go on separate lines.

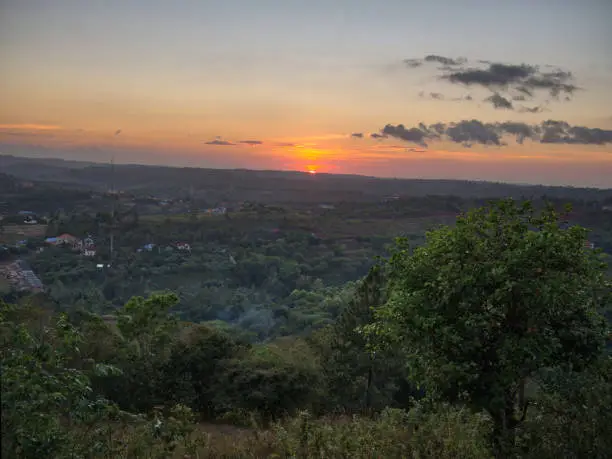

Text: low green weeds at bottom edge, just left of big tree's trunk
xmin=262 ymin=407 xmax=492 ymax=459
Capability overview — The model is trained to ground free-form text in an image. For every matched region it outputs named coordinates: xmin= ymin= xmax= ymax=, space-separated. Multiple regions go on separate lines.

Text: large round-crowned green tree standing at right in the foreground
xmin=371 ymin=200 xmax=610 ymax=455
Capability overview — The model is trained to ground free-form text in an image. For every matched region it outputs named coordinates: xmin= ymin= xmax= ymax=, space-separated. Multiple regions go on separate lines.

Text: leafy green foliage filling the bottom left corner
xmin=0 ymin=303 xmax=113 ymax=458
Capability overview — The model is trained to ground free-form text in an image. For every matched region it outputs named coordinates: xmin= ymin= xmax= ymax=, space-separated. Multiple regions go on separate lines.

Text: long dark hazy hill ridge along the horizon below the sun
xmin=0 ymin=156 xmax=612 ymax=203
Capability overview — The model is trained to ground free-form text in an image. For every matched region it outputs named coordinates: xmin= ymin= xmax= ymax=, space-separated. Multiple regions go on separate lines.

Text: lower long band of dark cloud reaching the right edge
xmin=372 ymin=120 xmax=612 ymax=147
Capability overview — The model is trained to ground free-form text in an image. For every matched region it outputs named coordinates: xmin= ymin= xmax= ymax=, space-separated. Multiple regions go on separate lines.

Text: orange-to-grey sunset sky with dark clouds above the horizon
xmin=0 ymin=0 xmax=612 ymax=187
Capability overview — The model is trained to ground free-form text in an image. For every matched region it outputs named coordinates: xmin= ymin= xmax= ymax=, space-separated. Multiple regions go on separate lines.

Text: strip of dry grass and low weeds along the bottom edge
xmin=68 ymin=408 xmax=492 ymax=459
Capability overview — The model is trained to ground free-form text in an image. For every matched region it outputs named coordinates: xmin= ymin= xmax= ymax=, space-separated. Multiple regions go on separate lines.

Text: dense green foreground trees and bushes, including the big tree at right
xmin=0 ymin=201 xmax=612 ymax=459
